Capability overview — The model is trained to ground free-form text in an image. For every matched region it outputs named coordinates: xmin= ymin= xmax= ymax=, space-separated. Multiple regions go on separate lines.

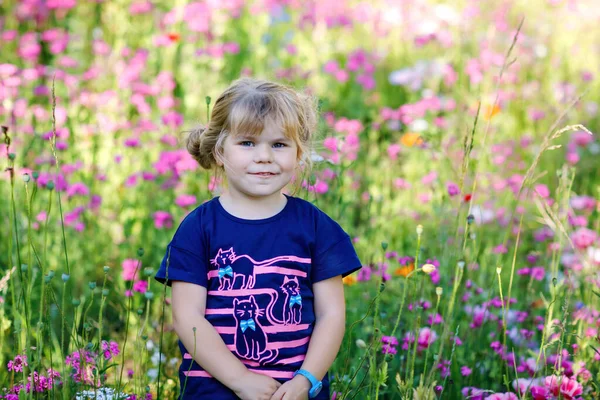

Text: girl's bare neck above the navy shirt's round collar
xmin=218 ymin=191 xmax=287 ymax=220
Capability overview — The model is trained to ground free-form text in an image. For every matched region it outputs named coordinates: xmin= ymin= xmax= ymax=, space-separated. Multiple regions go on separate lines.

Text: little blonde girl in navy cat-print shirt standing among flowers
xmin=156 ymin=78 xmax=361 ymax=400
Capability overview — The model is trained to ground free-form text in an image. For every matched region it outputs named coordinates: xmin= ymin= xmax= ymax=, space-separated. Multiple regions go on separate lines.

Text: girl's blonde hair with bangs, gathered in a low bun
xmin=186 ymin=78 xmax=318 ymax=193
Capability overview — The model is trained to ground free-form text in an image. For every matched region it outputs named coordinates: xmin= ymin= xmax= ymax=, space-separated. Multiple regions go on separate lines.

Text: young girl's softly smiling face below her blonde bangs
xmin=219 ymin=118 xmax=298 ymax=198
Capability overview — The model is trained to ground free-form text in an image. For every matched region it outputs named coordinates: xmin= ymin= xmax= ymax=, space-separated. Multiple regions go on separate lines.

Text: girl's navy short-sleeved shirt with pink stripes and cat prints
xmin=156 ymin=195 xmax=361 ymax=400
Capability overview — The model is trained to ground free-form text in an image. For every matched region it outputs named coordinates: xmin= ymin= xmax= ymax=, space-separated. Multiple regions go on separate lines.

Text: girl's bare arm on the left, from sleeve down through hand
xmin=171 ymin=281 xmax=281 ymax=399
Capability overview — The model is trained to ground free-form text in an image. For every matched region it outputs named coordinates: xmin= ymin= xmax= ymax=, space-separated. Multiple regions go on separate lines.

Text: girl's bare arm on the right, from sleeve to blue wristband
xmin=297 ymin=275 xmax=346 ymax=382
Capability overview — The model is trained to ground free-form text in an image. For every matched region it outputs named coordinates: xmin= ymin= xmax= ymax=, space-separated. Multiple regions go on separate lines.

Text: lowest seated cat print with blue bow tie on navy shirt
xmin=233 ymin=296 xmax=278 ymax=364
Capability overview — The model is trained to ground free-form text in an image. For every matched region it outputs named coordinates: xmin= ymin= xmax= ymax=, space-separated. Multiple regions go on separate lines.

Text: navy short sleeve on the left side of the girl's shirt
xmin=154 ymin=209 xmax=208 ymax=287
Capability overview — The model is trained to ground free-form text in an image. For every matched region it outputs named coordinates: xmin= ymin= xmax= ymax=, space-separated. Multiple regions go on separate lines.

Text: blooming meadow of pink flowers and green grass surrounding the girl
xmin=0 ymin=0 xmax=600 ymax=400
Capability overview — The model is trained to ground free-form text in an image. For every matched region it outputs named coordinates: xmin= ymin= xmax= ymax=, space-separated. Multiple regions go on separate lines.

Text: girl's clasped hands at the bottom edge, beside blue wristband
xmin=233 ymin=371 xmax=310 ymax=400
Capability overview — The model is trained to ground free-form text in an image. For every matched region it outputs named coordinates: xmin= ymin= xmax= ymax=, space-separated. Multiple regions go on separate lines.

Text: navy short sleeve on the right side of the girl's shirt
xmin=311 ymin=210 xmax=362 ymax=283
